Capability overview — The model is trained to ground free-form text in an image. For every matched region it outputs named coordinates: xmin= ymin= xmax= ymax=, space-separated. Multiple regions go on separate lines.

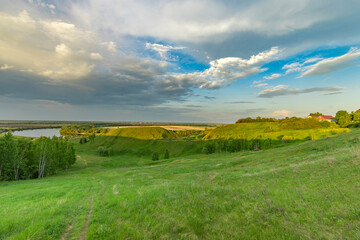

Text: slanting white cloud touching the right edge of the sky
xmin=301 ymin=48 xmax=360 ymax=77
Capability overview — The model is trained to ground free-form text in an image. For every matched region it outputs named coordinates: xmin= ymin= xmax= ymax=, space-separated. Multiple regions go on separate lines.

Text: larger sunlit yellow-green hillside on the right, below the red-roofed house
xmin=204 ymin=122 xmax=349 ymax=140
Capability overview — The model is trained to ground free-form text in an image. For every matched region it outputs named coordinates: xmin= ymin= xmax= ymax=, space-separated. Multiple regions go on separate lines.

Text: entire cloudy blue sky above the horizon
xmin=0 ymin=0 xmax=360 ymax=123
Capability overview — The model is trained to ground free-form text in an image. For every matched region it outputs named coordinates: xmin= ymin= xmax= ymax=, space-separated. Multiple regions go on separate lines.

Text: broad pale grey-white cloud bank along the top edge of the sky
xmin=70 ymin=0 xmax=343 ymax=42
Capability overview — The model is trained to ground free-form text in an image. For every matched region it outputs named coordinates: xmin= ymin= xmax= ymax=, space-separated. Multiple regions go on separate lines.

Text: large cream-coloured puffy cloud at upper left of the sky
xmin=0 ymin=11 xmax=100 ymax=80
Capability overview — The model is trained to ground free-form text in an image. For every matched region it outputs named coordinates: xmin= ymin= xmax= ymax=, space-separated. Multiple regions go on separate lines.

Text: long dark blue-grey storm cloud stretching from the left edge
xmin=0 ymin=58 xmax=200 ymax=106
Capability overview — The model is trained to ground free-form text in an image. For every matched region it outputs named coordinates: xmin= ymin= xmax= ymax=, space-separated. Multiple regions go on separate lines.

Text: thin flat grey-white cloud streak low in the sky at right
xmin=258 ymin=85 xmax=344 ymax=98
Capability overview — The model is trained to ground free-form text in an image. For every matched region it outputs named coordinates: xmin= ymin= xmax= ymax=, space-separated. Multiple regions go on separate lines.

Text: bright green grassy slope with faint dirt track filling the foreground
xmin=0 ymin=130 xmax=360 ymax=239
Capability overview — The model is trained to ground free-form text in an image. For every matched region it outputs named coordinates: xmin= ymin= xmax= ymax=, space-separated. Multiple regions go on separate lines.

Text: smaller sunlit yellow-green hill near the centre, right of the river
xmin=106 ymin=127 xmax=177 ymax=139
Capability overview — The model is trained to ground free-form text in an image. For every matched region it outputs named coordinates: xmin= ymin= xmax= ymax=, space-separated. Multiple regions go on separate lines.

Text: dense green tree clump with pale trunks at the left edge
xmin=0 ymin=132 xmax=76 ymax=181
